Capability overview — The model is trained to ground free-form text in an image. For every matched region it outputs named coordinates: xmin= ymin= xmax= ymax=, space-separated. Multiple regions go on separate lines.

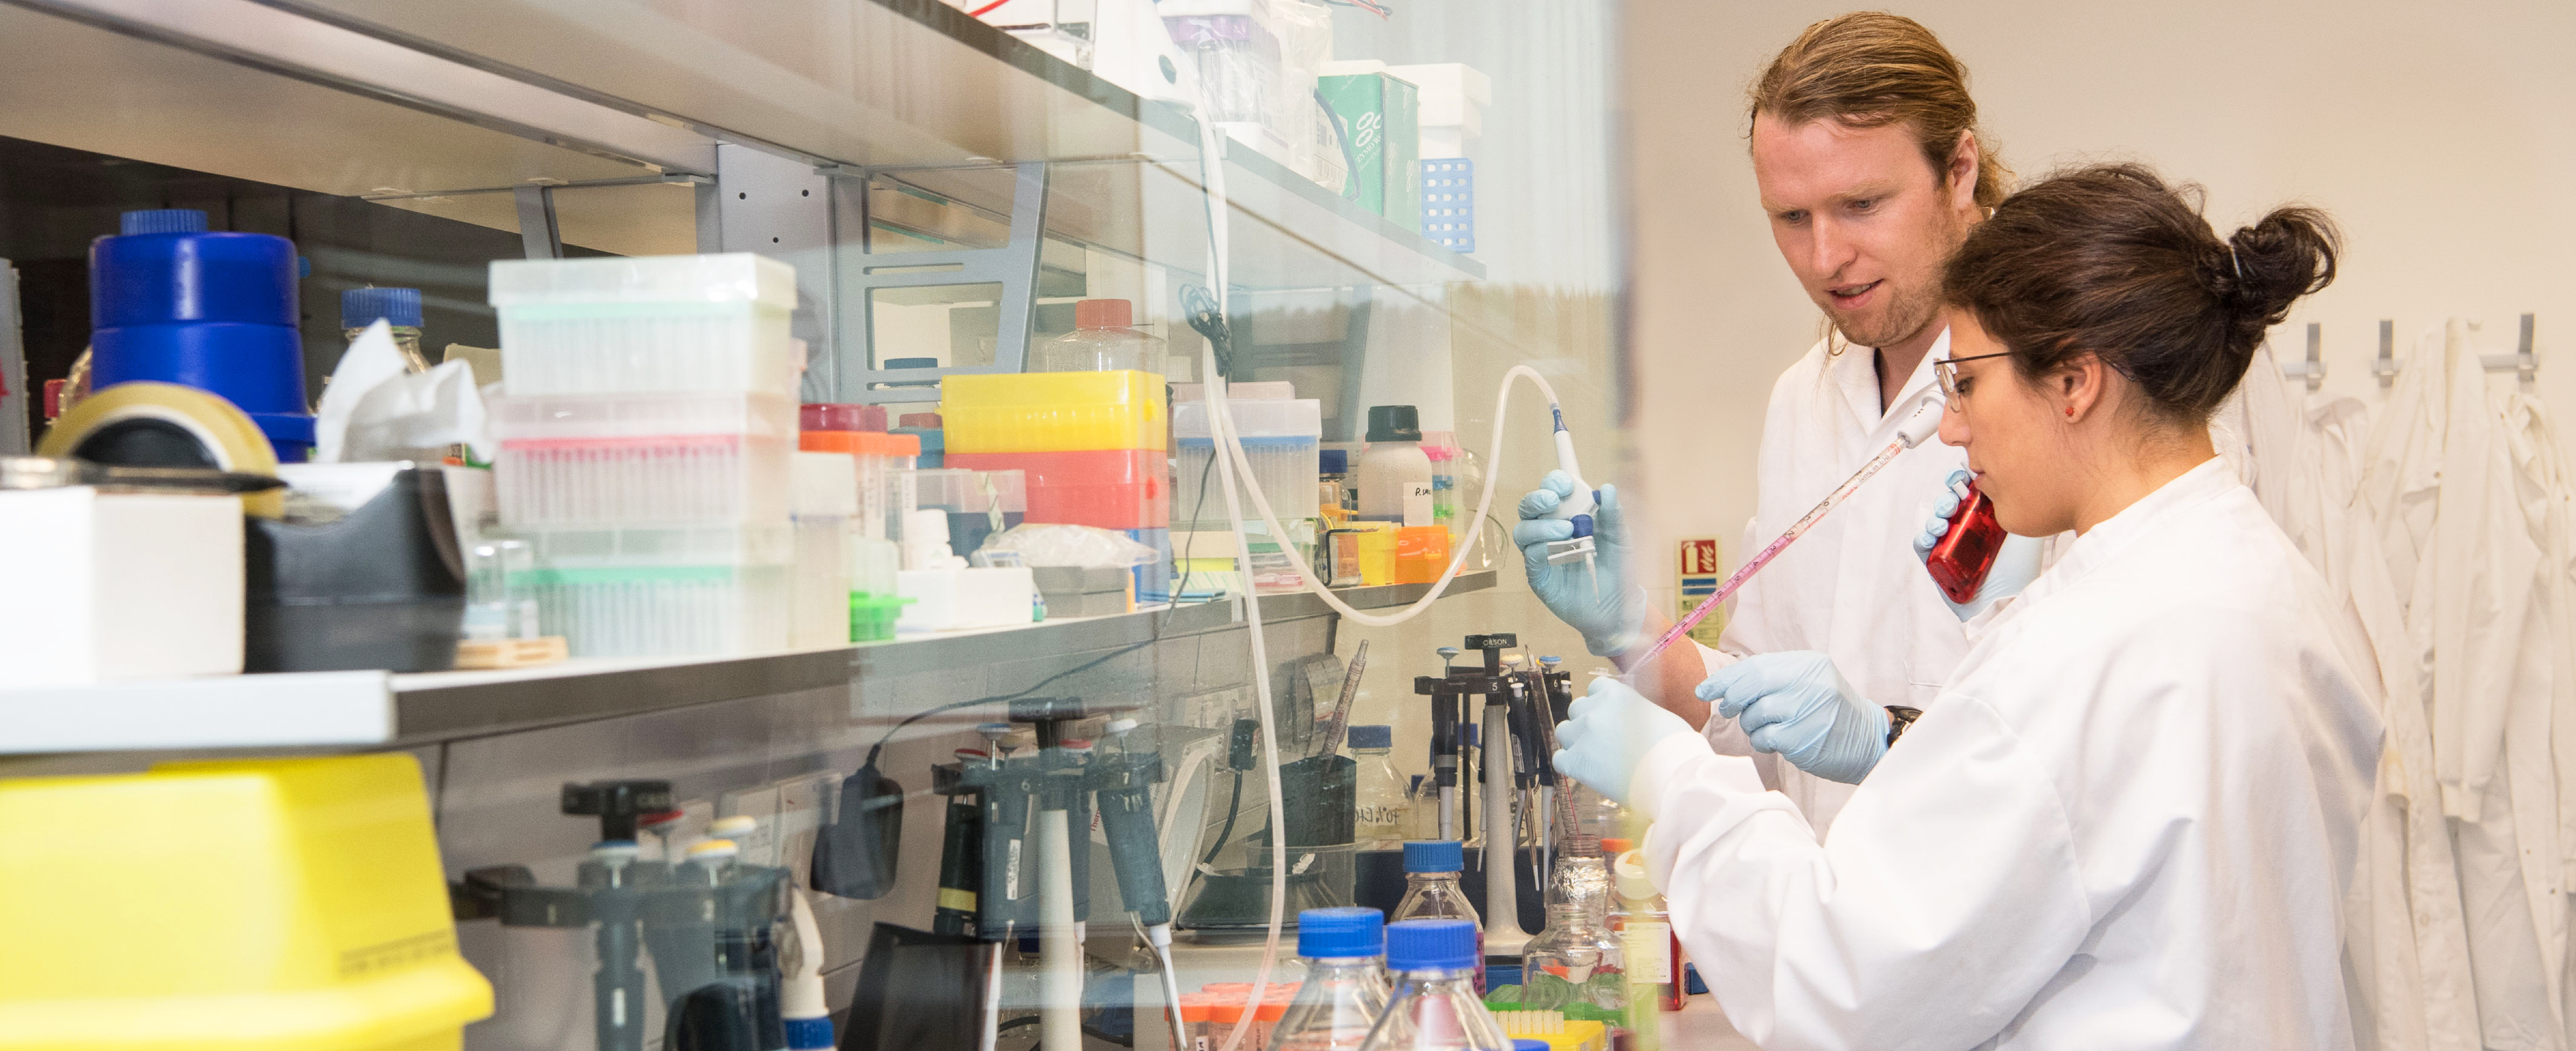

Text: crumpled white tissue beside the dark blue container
xmin=312 ymin=319 xmax=500 ymax=464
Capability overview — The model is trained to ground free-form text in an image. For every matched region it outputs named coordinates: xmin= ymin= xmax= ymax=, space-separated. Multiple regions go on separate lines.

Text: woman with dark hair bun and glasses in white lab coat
xmin=1558 ymin=165 xmax=2380 ymax=1051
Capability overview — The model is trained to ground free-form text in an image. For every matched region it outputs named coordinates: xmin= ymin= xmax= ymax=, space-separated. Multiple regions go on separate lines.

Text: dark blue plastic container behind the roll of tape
xmin=90 ymin=209 xmax=314 ymax=461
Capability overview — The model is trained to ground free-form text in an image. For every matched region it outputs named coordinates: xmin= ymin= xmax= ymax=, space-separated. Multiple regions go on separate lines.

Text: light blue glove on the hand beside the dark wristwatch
xmin=1690 ymin=649 xmax=1888 ymax=786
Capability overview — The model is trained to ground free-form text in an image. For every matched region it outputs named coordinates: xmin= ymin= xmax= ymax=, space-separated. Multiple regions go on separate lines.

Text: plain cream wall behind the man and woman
xmin=1623 ymin=0 xmax=2576 ymax=592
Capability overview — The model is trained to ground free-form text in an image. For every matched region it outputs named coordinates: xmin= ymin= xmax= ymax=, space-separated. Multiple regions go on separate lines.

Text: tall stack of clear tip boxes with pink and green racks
xmin=492 ymin=252 xmax=798 ymax=657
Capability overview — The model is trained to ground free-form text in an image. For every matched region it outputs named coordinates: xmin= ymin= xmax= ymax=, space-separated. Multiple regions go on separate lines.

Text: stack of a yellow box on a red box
xmin=941 ymin=352 xmax=1175 ymax=603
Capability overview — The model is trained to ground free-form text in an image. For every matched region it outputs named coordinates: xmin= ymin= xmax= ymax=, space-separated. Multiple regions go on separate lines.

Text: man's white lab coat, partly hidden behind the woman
xmin=1700 ymin=332 xmax=1968 ymax=835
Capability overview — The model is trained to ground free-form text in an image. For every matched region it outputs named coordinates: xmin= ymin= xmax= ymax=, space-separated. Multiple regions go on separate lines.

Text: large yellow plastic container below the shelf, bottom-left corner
xmin=0 ymin=752 xmax=492 ymax=1051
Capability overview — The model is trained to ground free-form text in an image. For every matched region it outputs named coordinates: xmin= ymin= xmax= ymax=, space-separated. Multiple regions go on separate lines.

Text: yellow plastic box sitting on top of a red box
xmin=941 ymin=371 xmax=1172 ymax=456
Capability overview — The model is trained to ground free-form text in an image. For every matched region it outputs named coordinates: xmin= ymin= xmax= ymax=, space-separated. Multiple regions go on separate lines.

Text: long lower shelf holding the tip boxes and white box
xmin=0 ymin=569 xmax=1494 ymax=755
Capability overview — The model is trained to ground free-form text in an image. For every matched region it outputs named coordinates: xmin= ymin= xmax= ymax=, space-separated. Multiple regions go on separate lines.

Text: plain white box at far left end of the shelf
xmin=0 ymin=487 xmax=242 ymax=688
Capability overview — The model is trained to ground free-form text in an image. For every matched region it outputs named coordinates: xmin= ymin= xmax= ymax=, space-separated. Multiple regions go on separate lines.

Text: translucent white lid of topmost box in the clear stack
xmin=490 ymin=252 xmax=796 ymax=309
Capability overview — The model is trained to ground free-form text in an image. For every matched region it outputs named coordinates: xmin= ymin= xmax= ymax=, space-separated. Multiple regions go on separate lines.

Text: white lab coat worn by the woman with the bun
xmin=1635 ymin=461 xmax=2380 ymax=1051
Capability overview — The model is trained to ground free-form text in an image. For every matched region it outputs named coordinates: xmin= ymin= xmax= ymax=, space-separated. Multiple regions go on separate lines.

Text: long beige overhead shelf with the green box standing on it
xmin=270 ymin=0 xmax=1484 ymax=289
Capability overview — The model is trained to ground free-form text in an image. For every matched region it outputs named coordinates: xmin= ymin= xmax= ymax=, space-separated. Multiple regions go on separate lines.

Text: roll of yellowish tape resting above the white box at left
xmin=36 ymin=381 xmax=286 ymax=517
